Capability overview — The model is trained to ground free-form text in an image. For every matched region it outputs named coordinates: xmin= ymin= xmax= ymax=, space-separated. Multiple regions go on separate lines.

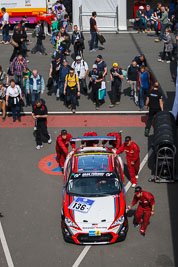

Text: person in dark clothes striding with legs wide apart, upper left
xmin=31 ymin=20 xmax=47 ymax=56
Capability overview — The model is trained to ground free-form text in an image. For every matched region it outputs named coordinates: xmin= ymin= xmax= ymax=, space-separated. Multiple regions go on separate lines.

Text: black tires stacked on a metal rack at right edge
xmin=154 ymin=111 xmax=176 ymax=181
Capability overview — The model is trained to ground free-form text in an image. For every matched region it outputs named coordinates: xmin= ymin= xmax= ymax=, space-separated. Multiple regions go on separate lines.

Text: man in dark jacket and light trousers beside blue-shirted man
xmin=126 ymin=60 xmax=139 ymax=106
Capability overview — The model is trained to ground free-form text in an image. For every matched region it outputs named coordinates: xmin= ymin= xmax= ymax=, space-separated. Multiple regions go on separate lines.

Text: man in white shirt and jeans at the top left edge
xmin=0 ymin=7 xmax=10 ymax=44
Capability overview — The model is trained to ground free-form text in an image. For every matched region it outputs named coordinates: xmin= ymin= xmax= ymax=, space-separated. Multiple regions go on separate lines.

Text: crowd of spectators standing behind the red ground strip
xmin=0 ymin=0 xmax=177 ymax=125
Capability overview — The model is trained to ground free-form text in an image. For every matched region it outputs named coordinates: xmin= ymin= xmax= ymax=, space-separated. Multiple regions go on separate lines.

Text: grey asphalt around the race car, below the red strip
xmin=0 ymin=116 xmax=178 ymax=267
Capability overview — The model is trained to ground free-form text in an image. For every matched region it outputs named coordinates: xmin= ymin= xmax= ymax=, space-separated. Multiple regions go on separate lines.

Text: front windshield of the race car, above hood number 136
xmin=67 ymin=176 xmax=121 ymax=197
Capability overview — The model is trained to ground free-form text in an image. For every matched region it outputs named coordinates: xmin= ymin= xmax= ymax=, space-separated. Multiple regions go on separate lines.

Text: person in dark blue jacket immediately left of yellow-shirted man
xmin=56 ymin=59 xmax=70 ymax=100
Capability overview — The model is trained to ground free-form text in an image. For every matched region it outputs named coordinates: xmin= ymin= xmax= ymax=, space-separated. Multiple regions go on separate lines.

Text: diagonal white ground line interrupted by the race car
xmin=72 ymin=148 xmax=153 ymax=267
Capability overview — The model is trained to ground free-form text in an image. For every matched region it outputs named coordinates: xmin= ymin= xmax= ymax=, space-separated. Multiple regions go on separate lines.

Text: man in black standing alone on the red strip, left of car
xmin=32 ymin=99 xmax=52 ymax=150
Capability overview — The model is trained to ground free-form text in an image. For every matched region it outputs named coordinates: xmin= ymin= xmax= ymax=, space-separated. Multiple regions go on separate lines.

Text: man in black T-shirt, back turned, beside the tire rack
xmin=145 ymin=82 xmax=163 ymax=136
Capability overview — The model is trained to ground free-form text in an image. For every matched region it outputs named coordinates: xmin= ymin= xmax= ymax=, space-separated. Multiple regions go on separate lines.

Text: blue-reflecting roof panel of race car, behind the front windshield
xmin=78 ymin=155 xmax=109 ymax=173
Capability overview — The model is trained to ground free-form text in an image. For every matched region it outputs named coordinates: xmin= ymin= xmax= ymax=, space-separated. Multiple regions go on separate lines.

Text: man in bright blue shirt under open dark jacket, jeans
xmin=137 ymin=66 xmax=153 ymax=110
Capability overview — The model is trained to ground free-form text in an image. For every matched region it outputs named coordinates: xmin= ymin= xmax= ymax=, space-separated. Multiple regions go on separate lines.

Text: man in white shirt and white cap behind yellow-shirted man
xmin=71 ymin=56 xmax=88 ymax=95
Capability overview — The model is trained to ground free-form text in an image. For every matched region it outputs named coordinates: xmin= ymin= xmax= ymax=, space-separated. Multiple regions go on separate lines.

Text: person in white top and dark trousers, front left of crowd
xmin=6 ymin=79 xmax=23 ymax=122
